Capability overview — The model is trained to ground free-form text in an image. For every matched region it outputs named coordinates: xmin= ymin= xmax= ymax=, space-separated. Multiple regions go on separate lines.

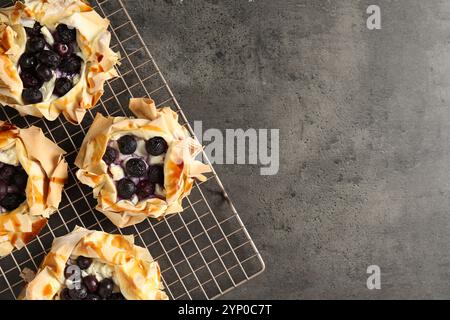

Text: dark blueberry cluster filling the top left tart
xmin=19 ymin=22 xmax=83 ymax=104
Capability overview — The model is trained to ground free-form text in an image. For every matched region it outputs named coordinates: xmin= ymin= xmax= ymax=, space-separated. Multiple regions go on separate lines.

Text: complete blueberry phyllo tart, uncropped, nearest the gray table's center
xmin=75 ymin=99 xmax=210 ymax=228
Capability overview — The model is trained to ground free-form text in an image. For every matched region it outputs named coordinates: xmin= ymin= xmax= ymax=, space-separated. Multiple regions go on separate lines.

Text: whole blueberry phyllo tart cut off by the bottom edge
xmin=21 ymin=227 xmax=168 ymax=300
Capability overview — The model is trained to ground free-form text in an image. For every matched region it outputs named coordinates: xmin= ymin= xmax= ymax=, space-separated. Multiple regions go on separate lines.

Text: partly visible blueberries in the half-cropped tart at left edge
xmin=0 ymin=162 xmax=28 ymax=211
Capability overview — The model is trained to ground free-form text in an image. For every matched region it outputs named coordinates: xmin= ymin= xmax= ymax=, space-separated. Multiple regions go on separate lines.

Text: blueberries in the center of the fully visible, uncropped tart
xmin=103 ymin=135 xmax=168 ymax=200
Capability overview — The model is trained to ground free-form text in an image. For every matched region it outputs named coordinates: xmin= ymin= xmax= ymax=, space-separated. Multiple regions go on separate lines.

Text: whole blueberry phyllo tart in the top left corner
xmin=0 ymin=0 xmax=118 ymax=123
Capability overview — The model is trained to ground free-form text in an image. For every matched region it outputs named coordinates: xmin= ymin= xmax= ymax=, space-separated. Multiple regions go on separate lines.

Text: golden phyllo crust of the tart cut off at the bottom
xmin=23 ymin=227 xmax=168 ymax=300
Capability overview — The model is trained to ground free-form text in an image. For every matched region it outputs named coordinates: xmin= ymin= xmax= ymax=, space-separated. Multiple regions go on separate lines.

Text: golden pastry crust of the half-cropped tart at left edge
xmin=0 ymin=121 xmax=67 ymax=256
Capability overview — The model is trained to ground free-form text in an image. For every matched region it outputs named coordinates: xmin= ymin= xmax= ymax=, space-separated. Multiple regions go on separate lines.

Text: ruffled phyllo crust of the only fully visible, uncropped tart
xmin=75 ymin=99 xmax=211 ymax=228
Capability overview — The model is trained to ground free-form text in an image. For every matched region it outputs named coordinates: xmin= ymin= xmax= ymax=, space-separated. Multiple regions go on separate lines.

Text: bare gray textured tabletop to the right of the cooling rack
xmin=127 ymin=0 xmax=450 ymax=299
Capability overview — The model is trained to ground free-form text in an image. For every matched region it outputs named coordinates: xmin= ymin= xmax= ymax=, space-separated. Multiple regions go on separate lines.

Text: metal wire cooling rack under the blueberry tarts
xmin=0 ymin=0 xmax=264 ymax=299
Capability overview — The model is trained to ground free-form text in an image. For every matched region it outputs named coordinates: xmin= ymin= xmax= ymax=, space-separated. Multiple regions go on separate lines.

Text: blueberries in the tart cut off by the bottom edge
xmin=60 ymin=256 xmax=125 ymax=300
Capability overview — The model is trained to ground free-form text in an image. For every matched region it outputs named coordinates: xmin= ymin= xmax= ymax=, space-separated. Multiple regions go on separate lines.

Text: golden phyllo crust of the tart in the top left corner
xmin=0 ymin=0 xmax=119 ymax=123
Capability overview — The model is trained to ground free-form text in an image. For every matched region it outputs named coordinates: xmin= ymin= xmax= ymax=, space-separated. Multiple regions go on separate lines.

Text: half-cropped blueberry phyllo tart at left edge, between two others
xmin=0 ymin=121 xmax=67 ymax=256
